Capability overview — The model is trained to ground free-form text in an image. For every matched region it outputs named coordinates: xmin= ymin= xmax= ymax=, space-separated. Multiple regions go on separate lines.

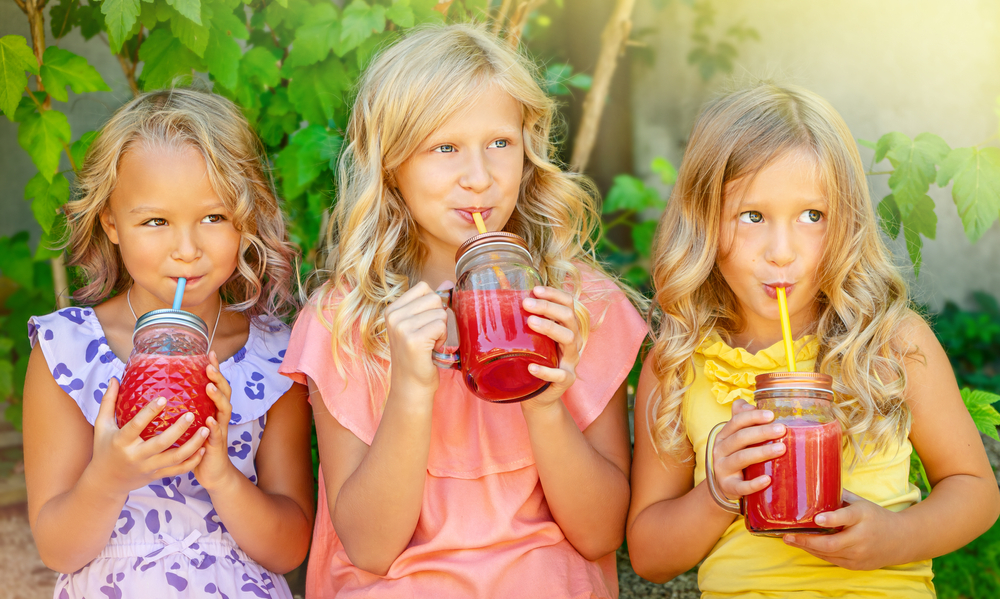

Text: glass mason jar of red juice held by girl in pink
xmin=434 ymin=232 xmax=559 ymax=403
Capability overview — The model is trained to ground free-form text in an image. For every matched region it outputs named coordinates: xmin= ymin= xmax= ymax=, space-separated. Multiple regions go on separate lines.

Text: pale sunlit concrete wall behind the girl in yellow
xmin=632 ymin=0 xmax=1000 ymax=306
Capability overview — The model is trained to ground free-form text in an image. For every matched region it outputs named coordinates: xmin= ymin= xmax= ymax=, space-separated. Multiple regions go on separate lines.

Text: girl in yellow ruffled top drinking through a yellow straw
xmin=627 ymin=83 xmax=1000 ymax=598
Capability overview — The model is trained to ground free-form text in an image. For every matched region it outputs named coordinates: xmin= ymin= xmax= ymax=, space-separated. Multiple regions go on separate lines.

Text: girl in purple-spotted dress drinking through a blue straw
xmin=24 ymin=90 xmax=314 ymax=599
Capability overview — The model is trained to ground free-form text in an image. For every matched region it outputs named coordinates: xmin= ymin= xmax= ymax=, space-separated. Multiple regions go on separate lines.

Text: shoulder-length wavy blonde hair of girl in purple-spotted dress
xmin=66 ymin=89 xmax=299 ymax=318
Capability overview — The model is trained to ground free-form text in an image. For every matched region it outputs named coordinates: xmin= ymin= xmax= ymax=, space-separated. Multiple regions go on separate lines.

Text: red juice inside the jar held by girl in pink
xmin=452 ymin=289 xmax=559 ymax=402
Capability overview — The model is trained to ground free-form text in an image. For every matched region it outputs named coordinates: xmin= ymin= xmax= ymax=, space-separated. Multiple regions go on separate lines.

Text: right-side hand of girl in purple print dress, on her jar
xmin=194 ymin=351 xmax=242 ymax=493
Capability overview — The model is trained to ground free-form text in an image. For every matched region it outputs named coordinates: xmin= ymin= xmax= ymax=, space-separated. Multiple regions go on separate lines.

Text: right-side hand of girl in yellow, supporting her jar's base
xmin=784 ymin=489 xmax=899 ymax=570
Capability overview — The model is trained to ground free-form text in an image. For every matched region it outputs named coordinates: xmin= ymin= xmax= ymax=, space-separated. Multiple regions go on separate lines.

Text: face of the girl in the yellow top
xmin=718 ymin=151 xmax=828 ymax=341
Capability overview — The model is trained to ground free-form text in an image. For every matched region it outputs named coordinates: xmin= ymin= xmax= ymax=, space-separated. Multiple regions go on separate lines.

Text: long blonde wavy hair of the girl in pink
xmin=317 ymin=24 xmax=632 ymax=402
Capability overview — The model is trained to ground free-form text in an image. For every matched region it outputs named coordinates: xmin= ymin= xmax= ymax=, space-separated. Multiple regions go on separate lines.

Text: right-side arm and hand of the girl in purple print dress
xmin=194 ymin=360 xmax=315 ymax=574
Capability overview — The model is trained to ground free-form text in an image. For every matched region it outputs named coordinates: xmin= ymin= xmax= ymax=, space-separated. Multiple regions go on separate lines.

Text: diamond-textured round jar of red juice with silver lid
xmin=115 ymin=309 xmax=216 ymax=447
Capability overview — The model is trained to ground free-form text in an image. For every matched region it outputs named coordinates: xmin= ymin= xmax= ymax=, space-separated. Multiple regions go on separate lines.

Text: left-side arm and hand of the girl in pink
xmin=309 ymin=282 xmax=448 ymax=576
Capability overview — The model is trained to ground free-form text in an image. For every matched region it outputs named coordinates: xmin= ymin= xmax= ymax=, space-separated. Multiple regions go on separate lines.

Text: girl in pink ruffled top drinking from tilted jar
xmin=281 ymin=25 xmax=646 ymax=599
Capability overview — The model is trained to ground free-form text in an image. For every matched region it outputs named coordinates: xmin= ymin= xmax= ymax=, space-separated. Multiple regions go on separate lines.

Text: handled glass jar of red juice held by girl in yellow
xmin=706 ymin=372 xmax=843 ymax=536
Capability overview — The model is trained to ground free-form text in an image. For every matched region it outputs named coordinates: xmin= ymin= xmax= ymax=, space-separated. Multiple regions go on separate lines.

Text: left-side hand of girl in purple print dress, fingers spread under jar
xmin=91 ymin=379 xmax=207 ymax=494
